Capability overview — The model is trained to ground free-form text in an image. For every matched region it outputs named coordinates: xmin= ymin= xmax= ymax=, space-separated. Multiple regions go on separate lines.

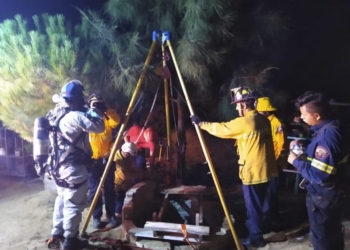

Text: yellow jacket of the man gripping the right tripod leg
xmin=201 ymin=110 xmax=278 ymax=185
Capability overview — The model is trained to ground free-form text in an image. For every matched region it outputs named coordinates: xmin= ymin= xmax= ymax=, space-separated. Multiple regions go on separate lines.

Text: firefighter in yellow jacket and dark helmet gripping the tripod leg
xmin=191 ymin=87 xmax=277 ymax=247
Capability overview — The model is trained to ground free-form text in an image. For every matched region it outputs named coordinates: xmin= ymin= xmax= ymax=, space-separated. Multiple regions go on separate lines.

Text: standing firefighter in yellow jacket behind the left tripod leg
xmin=88 ymin=94 xmax=120 ymax=228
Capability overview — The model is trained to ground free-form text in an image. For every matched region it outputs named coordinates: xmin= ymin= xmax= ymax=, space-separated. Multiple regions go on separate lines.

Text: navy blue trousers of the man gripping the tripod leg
xmin=243 ymin=182 xmax=270 ymax=241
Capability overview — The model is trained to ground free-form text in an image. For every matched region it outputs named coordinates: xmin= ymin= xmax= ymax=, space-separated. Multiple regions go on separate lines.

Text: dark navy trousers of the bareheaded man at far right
xmin=306 ymin=194 xmax=344 ymax=250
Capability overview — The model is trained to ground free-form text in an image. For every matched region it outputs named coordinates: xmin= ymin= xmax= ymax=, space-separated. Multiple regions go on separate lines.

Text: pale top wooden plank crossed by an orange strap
xmin=144 ymin=221 xmax=209 ymax=235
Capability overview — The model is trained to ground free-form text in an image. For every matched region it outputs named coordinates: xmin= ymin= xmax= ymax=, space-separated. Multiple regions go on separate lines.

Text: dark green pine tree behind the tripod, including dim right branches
xmin=85 ymin=0 xmax=283 ymax=175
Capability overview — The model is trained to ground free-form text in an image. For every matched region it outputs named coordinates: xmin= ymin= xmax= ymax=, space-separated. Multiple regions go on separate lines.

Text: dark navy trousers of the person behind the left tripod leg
xmin=89 ymin=159 xmax=115 ymax=219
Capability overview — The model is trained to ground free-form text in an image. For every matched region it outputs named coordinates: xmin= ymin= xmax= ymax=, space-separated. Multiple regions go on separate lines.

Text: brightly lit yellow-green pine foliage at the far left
xmin=0 ymin=14 xmax=101 ymax=141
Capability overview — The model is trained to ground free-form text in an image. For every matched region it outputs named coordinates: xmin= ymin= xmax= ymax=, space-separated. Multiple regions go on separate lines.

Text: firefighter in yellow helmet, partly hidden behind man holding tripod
xmin=256 ymin=97 xmax=287 ymax=230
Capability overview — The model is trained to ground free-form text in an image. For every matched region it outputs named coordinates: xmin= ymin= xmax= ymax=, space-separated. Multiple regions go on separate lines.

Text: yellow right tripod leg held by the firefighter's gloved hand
xmin=163 ymin=32 xmax=243 ymax=250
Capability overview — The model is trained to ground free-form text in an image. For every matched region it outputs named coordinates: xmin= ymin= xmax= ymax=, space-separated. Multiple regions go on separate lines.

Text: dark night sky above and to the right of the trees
xmin=0 ymin=0 xmax=350 ymax=102
